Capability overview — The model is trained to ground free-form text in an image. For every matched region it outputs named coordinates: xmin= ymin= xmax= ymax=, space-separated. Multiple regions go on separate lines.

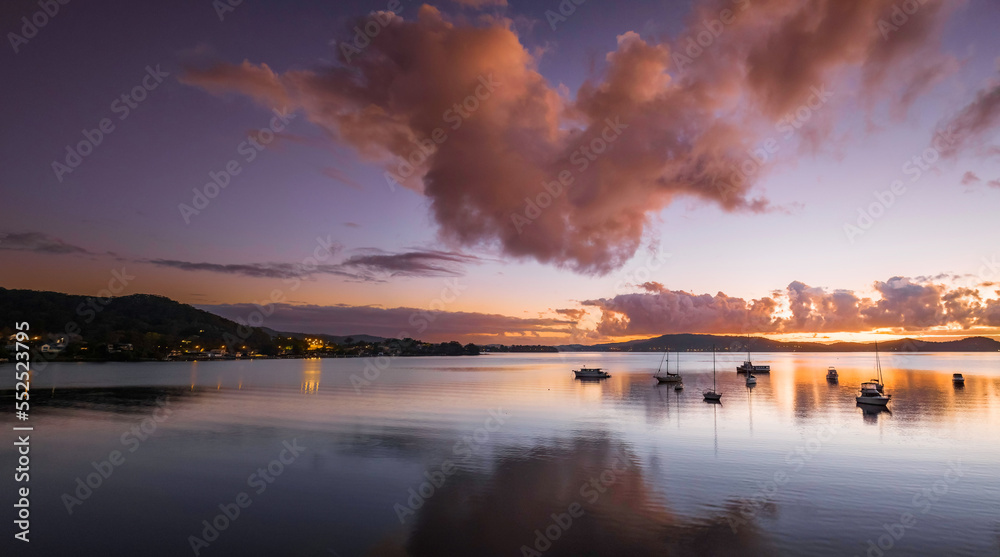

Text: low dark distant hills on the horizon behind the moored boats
xmin=557 ymin=334 xmax=1000 ymax=352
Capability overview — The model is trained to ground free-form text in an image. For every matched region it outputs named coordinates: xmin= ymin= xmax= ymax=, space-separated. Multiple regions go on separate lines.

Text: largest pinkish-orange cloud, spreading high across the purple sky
xmin=180 ymin=0 xmax=953 ymax=274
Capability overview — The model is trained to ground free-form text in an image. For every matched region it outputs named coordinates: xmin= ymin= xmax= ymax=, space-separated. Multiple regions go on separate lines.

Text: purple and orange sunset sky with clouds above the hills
xmin=0 ymin=0 xmax=1000 ymax=344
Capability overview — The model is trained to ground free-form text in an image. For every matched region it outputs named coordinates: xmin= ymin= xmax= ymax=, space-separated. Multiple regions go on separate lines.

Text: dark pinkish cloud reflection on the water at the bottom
xmin=369 ymin=436 xmax=776 ymax=557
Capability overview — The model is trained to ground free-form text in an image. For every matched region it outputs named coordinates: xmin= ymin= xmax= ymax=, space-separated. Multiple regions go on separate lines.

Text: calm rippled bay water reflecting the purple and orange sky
xmin=0 ymin=354 xmax=1000 ymax=557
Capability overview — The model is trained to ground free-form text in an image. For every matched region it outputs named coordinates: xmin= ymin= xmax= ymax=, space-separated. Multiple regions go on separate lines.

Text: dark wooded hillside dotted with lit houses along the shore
xmin=0 ymin=288 xmax=480 ymax=361
